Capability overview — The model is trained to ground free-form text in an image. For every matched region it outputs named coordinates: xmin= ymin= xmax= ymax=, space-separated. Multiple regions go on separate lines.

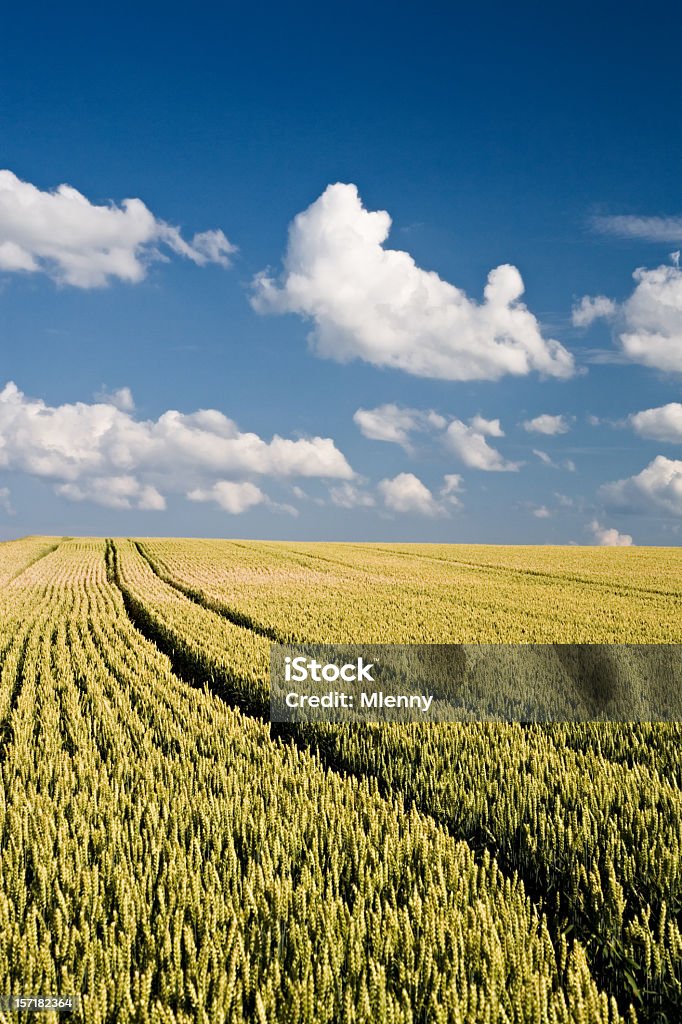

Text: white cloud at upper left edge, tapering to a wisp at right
xmin=0 ymin=170 xmax=236 ymax=288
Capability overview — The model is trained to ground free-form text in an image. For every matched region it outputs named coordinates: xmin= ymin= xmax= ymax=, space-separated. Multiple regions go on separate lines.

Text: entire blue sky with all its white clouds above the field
xmin=0 ymin=3 xmax=682 ymax=545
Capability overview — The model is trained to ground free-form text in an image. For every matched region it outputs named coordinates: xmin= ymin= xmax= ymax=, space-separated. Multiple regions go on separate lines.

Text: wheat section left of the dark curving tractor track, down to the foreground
xmin=0 ymin=541 xmax=622 ymax=1024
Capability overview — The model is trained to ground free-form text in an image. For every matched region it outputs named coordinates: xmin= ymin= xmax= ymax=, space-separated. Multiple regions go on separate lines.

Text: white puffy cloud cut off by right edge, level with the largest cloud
xmin=577 ymin=264 xmax=682 ymax=373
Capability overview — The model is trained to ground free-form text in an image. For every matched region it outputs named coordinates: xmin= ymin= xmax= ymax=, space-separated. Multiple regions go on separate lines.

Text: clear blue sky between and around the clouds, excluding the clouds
xmin=0 ymin=2 xmax=682 ymax=544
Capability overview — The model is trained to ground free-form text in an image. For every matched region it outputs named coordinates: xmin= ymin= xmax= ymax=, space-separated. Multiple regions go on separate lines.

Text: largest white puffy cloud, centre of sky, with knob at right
xmin=252 ymin=183 xmax=574 ymax=380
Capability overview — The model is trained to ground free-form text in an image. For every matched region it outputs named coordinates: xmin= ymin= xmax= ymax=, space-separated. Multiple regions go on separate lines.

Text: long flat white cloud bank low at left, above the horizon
xmin=0 ymin=383 xmax=354 ymax=509
